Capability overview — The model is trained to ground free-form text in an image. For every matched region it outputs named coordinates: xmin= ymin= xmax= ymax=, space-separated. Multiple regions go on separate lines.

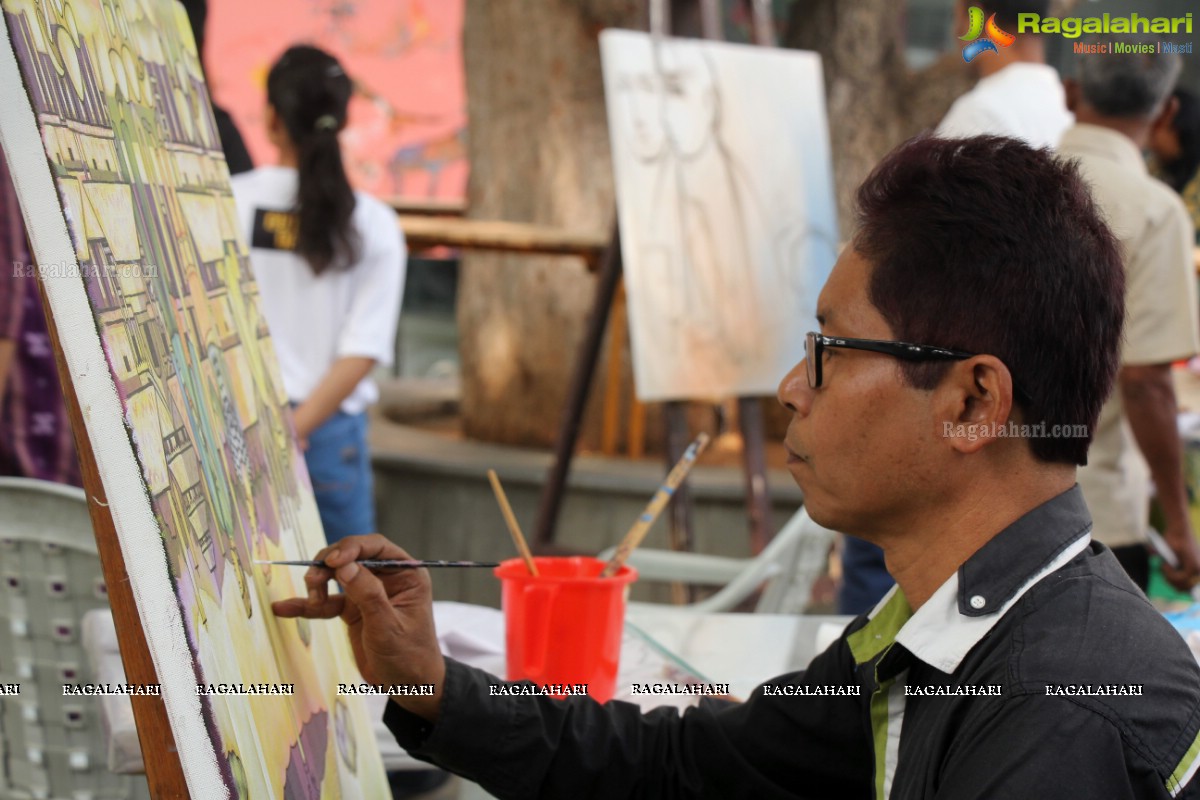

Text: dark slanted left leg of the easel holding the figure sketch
xmin=533 ymin=223 xmax=622 ymax=547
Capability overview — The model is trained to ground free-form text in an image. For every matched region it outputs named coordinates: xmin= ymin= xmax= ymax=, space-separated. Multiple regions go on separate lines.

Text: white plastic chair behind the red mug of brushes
xmin=600 ymin=509 xmax=838 ymax=614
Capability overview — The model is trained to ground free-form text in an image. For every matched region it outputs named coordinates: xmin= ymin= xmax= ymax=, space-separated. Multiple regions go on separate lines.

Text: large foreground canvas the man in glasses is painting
xmin=0 ymin=0 xmax=388 ymax=800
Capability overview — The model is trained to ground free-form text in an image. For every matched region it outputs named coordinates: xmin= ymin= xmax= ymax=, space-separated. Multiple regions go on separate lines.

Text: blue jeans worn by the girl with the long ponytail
xmin=304 ymin=411 xmax=377 ymax=543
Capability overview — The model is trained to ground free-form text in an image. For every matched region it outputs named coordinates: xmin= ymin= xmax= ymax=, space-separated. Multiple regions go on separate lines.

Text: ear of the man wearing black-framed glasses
xmin=935 ymin=355 xmax=1014 ymax=453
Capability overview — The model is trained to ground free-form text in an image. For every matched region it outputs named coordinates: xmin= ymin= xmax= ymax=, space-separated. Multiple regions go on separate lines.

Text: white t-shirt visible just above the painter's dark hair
xmin=937 ymin=61 xmax=1075 ymax=148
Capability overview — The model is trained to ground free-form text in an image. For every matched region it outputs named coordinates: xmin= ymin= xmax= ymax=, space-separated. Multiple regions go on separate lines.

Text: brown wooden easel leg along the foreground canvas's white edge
xmin=37 ymin=281 xmax=190 ymax=800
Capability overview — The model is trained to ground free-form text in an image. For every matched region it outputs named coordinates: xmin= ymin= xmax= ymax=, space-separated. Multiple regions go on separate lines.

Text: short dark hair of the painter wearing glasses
xmin=852 ymin=137 xmax=1124 ymax=464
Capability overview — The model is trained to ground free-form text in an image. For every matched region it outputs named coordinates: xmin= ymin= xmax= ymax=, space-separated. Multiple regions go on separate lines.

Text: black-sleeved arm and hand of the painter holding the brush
xmin=272 ymin=535 xmax=874 ymax=800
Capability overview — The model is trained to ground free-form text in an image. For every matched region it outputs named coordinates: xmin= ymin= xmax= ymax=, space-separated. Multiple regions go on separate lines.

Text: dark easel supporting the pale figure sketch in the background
xmin=534 ymin=0 xmax=774 ymax=568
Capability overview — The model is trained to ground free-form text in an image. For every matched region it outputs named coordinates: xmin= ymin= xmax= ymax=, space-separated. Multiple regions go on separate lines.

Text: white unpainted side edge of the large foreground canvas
xmin=0 ymin=9 xmax=229 ymax=799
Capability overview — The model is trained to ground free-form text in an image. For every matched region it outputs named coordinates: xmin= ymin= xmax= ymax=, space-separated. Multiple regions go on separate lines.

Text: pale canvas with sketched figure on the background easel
xmin=600 ymin=30 xmax=838 ymax=401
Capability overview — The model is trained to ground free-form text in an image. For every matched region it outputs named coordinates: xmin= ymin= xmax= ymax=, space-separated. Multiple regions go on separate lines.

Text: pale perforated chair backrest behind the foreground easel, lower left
xmin=0 ymin=477 xmax=149 ymax=800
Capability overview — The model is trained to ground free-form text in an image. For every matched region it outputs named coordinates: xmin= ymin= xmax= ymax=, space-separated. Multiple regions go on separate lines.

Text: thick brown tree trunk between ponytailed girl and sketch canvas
xmin=457 ymin=0 xmax=646 ymax=446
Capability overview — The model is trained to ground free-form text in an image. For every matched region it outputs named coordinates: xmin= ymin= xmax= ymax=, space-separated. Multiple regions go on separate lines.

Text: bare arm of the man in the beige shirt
xmin=1117 ymin=363 xmax=1200 ymax=590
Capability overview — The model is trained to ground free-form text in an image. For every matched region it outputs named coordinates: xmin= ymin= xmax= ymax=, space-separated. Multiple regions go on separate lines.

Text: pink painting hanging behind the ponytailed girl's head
xmin=204 ymin=0 xmax=467 ymax=200
